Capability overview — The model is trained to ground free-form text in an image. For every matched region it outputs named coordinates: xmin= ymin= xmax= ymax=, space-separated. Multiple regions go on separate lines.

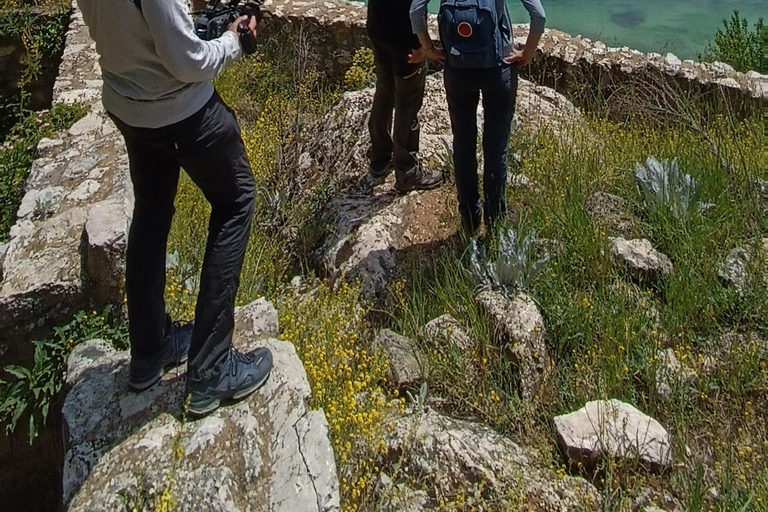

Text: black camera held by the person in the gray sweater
xmin=193 ymin=0 xmax=264 ymax=54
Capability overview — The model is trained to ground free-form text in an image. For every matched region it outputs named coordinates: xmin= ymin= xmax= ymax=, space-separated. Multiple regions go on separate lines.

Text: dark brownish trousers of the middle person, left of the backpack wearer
xmin=368 ymin=40 xmax=426 ymax=171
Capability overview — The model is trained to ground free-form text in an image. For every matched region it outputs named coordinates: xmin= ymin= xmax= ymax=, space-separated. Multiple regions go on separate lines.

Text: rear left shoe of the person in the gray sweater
xmin=128 ymin=317 xmax=195 ymax=391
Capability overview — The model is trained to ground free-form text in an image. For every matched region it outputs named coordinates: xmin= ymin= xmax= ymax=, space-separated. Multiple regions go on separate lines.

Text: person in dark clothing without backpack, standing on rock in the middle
xmin=367 ymin=0 xmax=443 ymax=192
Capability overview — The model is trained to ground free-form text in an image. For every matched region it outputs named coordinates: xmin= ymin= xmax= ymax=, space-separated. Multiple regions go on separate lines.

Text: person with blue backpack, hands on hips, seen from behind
xmin=411 ymin=0 xmax=546 ymax=234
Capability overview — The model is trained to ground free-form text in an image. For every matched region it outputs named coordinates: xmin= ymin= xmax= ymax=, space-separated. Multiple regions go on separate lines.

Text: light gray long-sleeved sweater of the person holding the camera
xmin=77 ymin=0 xmax=242 ymax=128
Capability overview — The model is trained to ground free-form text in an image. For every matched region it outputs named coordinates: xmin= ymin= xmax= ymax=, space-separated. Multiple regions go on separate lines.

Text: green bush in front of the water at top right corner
xmin=699 ymin=9 xmax=768 ymax=73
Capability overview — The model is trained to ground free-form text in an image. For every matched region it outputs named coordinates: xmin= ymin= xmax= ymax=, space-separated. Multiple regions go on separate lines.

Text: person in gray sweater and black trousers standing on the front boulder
xmin=77 ymin=0 xmax=272 ymax=415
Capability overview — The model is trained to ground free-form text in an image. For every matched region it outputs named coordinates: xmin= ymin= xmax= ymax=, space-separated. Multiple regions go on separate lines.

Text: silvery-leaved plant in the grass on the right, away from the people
xmin=635 ymin=157 xmax=713 ymax=220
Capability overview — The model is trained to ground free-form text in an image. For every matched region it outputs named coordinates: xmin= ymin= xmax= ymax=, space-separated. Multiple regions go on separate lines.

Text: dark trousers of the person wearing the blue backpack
xmin=444 ymin=65 xmax=517 ymax=227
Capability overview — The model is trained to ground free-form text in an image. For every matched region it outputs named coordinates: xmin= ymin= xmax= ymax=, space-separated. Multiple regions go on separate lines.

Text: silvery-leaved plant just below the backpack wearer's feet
xmin=469 ymin=228 xmax=549 ymax=295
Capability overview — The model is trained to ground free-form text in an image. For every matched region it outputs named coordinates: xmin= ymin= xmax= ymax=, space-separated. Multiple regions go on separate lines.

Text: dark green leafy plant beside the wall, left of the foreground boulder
xmin=0 ymin=307 xmax=128 ymax=444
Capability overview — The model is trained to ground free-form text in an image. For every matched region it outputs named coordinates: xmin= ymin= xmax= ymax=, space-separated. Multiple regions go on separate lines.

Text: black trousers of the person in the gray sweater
xmin=112 ymin=93 xmax=254 ymax=378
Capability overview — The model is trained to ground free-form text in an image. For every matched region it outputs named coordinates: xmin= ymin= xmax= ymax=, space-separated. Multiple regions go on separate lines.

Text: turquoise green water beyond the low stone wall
xmin=356 ymin=0 xmax=768 ymax=59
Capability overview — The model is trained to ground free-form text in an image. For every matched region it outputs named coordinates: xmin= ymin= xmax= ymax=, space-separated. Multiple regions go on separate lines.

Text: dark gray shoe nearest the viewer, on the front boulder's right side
xmin=187 ymin=347 xmax=272 ymax=416
